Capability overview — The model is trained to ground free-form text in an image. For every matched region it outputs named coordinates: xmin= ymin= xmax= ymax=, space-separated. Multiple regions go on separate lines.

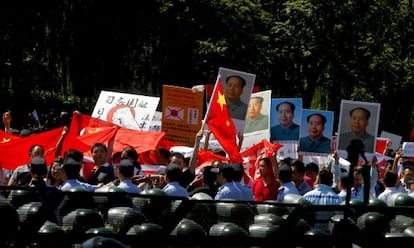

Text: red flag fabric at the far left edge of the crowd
xmin=0 ymin=127 xmax=63 ymax=170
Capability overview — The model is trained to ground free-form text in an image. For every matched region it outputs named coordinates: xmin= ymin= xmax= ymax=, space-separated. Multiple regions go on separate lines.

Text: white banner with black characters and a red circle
xmin=92 ymin=90 xmax=160 ymax=131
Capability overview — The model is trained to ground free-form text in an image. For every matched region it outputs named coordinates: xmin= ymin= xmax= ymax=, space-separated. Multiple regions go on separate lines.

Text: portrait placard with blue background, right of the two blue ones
xmin=299 ymin=109 xmax=334 ymax=156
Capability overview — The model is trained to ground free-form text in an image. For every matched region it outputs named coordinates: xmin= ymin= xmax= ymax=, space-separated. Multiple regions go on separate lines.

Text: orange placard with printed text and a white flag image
xmin=161 ymin=85 xmax=204 ymax=146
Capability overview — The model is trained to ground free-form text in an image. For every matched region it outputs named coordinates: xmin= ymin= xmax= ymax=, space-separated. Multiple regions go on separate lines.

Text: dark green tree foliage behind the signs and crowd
xmin=0 ymin=0 xmax=414 ymax=137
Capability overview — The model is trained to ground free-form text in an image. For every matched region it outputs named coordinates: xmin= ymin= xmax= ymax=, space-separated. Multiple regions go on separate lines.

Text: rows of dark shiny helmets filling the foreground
xmin=0 ymin=186 xmax=414 ymax=248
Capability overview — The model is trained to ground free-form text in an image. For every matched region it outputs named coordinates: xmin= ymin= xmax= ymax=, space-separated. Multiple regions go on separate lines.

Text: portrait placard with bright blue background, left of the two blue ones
xmin=270 ymin=98 xmax=302 ymax=143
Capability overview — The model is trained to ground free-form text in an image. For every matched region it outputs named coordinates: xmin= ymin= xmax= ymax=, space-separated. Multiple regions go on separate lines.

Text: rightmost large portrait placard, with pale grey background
xmin=336 ymin=100 xmax=381 ymax=158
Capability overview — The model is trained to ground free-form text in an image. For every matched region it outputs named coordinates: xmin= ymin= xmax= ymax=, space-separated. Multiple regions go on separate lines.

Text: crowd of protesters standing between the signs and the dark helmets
xmin=2 ymin=109 xmax=414 ymax=246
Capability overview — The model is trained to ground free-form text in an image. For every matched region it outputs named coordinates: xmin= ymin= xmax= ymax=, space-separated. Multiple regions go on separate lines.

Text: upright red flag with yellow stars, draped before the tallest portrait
xmin=206 ymin=75 xmax=243 ymax=163
